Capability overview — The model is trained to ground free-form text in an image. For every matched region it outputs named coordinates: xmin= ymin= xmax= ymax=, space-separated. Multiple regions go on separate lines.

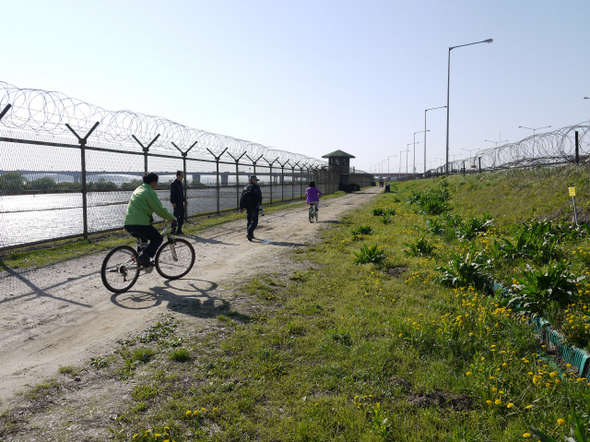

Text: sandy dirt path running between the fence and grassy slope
xmin=0 ymin=187 xmax=381 ymax=408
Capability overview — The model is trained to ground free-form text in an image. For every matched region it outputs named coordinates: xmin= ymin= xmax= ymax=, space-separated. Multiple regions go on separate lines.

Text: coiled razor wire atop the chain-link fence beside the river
xmin=0 ymin=81 xmax=327 ymax=168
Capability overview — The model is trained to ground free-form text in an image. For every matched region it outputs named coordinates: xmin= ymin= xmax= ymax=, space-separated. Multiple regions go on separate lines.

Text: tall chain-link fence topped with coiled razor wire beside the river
xmin=0 ymin=82 xmax=371 ymax=251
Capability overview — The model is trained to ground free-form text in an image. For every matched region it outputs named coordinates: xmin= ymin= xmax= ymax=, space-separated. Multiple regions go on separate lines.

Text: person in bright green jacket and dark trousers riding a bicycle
xmin=123 ymin=172 xmax=176 ymax=267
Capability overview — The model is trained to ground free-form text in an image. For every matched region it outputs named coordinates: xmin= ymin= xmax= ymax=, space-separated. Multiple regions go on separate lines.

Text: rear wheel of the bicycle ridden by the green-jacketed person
xmin=100 ymin=246 xmax=139 ymax=293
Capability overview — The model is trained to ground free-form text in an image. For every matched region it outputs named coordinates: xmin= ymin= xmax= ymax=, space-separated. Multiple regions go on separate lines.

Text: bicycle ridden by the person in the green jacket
xmin=100 ymin=224 xmax=195 ymax=293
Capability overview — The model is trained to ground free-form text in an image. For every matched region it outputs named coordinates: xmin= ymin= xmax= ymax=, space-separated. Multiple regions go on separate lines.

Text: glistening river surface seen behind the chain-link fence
xmin=0 ymin=185 xmax=305 ymax=250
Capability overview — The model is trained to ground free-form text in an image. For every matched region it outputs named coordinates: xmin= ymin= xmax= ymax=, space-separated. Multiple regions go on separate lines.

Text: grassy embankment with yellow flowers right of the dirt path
xmin=3 ymin=167 xmax=590 ymax=442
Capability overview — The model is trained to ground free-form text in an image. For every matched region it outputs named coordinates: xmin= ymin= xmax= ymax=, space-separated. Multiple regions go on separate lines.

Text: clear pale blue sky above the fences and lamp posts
xmin=0 ymin=0 xmax=590 ymax=172
